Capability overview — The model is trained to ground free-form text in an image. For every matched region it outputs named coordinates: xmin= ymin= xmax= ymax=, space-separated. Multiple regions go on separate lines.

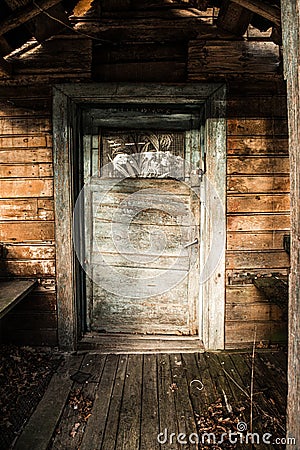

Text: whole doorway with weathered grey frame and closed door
xmin=54 ymin=84 xmax=226 ymax=349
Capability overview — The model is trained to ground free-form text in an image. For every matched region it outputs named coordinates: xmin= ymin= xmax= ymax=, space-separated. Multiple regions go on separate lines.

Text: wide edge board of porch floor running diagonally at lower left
xmin=14 ymin=355 xmax=83 ymax=450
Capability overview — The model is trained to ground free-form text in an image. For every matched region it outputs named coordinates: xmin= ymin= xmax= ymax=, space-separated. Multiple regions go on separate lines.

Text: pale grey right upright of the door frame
xmin=199 ymin=87 xmax=226 ymax=349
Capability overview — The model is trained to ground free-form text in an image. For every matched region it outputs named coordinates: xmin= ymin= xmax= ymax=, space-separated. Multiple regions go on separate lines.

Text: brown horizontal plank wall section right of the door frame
xmin=225 ymin=82 xmax=290 ymax=348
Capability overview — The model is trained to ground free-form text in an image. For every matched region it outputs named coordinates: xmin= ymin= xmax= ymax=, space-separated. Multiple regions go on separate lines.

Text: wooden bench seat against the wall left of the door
xmin=0 ymin=280 xmax=37 ymax=319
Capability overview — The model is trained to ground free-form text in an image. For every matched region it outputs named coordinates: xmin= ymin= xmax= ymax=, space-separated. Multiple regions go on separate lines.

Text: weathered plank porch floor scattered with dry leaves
xmin=14 ymin=350 xmax=286 ymax=450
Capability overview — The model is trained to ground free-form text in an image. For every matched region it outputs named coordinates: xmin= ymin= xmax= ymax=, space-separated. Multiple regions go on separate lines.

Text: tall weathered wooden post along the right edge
xmin=281 ymin=0 xmax=300 ymax=449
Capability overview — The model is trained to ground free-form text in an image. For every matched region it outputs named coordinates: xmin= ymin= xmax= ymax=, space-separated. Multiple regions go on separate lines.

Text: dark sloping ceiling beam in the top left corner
xmin=0 ymin=0 xmax=61 ymax=36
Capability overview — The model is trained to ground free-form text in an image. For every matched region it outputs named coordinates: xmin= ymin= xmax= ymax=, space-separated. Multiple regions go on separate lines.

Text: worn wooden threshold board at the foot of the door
xmin=78 ymin=332 xmax=204 ymax=354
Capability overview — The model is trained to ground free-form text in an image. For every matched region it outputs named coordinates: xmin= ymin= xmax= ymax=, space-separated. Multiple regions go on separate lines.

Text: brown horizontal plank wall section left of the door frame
xmin=0 ymin=86 xmax=57 ymax=345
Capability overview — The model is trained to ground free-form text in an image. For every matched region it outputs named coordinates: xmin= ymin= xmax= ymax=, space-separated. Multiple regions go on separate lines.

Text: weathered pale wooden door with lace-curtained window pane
xmin=84 ymin=110 xmax=200 ymax=335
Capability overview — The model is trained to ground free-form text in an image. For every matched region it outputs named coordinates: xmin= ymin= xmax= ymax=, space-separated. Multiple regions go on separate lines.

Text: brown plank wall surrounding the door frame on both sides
xmin=0 ymin=7 xmax=289 ymax=348
